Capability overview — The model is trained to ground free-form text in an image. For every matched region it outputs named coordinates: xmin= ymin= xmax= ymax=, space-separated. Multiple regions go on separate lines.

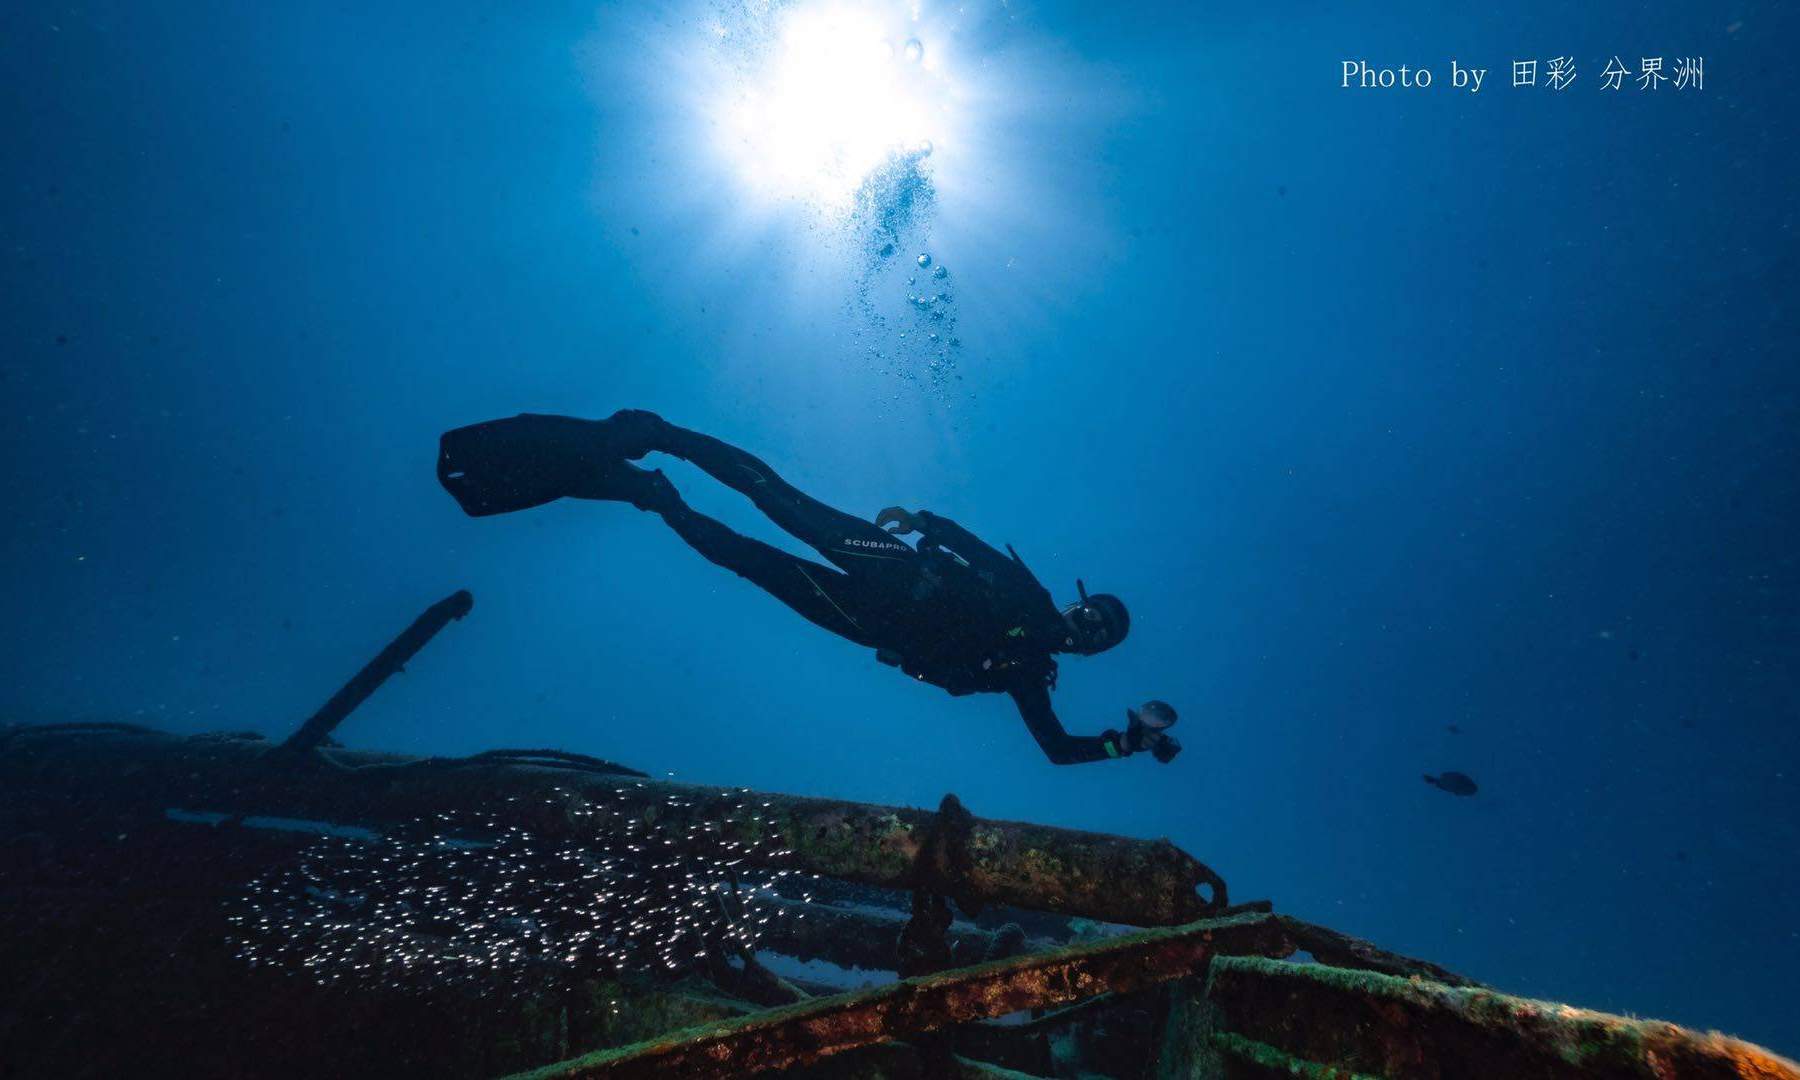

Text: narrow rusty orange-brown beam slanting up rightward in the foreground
xmin=507 ymin=914 xmax=1292 ymax=1080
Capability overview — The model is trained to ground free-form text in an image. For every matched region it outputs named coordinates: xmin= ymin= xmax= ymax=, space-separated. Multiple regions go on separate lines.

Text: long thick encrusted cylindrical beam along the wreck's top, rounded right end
xmin=0 ymin=729 xmax=1226 ymax=925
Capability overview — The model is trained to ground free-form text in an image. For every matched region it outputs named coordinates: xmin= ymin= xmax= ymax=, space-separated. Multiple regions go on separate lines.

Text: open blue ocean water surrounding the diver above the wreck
xmin=0 ymin=2 xmax=1800 ymax=1055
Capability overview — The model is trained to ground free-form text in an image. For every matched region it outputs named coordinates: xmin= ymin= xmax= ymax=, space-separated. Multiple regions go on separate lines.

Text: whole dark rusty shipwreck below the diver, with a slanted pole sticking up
xmin=0 ymin=592 xmax=1800 ymax=1080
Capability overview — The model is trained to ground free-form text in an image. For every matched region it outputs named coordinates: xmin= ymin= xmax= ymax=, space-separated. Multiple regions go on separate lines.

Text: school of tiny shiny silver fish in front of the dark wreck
xmin=227 ymin=788 xmax=815 ymax=986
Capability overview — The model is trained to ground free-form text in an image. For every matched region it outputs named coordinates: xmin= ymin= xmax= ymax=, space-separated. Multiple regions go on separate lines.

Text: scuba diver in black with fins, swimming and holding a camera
xmin=437 ymin=409 xmax=1181 ymax=765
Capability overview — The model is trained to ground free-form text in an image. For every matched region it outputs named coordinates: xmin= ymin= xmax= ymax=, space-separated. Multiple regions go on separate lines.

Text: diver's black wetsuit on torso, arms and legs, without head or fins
xmin=652 ymin=425 xmax=1125 ymax=765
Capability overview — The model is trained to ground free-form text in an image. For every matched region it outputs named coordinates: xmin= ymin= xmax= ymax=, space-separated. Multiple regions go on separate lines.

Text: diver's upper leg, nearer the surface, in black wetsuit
xmin=607 ymin=410 xmax=918 ymax=574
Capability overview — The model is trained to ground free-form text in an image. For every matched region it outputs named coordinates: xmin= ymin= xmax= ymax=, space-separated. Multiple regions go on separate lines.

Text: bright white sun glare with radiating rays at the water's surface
xmin=585 ymin=0 xmax=1118 ymax=401
